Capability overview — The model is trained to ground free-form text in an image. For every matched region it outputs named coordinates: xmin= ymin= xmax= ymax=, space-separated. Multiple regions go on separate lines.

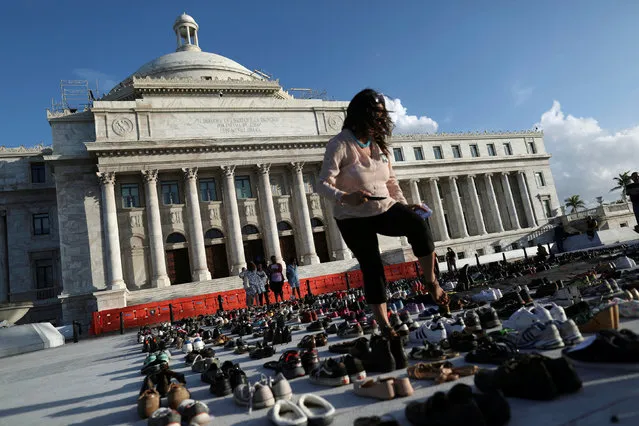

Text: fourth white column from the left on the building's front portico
xmin=222 ymin=166 xmax=246 ymax=275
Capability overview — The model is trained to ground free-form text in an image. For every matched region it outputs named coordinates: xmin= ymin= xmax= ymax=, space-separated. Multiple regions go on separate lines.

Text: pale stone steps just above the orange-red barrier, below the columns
xmin=126 ymin=259 xmax=359 ymax=306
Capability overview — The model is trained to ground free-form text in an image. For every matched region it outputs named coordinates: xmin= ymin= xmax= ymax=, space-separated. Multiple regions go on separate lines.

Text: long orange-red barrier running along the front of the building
xmin=90 ymin=262 xmax=418 ymax=335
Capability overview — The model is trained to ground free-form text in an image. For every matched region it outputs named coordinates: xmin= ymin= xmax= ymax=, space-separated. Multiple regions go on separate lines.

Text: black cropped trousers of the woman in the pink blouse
xmin=336 ymin=203 xmax=435 ymax=305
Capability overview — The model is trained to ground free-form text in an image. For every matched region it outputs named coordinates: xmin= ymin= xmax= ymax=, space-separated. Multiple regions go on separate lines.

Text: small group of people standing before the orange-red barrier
xmin=240 ymin=256 xmax=302 ymax=307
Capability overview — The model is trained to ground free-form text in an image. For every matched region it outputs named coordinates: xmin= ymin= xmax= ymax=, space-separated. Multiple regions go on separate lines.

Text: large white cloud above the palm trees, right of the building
xmin=535 ymin=101 xmax=639 ymax=205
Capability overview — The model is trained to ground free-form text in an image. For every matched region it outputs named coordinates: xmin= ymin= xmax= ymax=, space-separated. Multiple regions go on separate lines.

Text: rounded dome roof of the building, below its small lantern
xmin=133 ymin=51 xmax=260 ymax=80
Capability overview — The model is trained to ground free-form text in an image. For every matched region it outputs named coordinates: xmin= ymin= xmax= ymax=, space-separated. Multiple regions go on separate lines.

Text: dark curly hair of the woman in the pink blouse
xmin=342 ymin=89 xmax=393 ymax=154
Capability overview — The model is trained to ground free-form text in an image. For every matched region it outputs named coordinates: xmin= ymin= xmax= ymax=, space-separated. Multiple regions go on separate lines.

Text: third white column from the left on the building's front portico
xmin=182 ymin=167 xmax=211 ymax=281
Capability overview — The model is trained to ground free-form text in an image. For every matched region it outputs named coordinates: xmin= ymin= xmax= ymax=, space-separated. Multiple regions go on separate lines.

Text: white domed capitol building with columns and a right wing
xmin=0 ymin=15 xmax=560 ymax=324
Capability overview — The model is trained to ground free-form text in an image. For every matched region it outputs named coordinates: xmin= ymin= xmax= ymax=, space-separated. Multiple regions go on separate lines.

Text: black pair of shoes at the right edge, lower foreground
xmin=562 ymin=329 xmax=639 ymax=370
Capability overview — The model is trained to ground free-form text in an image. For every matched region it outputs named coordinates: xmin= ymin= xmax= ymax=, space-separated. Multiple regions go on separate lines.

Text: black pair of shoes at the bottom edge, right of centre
xmin=405 ymin=383 xmax=510 ymax=426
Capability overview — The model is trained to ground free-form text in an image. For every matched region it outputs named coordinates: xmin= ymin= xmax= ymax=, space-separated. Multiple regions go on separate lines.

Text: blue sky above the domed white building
xmin=0 ymin=0 xmax=639 ymax=200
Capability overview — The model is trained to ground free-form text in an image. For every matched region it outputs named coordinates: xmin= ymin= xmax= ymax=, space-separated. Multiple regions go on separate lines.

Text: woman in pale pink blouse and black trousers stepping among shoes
xmin=318 ymin=89 xmax=448 ymax=336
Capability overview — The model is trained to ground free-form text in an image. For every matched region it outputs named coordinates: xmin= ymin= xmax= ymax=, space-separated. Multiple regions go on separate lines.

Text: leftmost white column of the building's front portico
xmin=96 ymin=172 xmax=126 ymax=290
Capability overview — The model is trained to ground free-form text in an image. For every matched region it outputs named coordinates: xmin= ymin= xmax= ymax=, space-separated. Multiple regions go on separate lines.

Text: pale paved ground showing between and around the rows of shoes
xmin=0 ymin=265 xmax=639 ymax=426
